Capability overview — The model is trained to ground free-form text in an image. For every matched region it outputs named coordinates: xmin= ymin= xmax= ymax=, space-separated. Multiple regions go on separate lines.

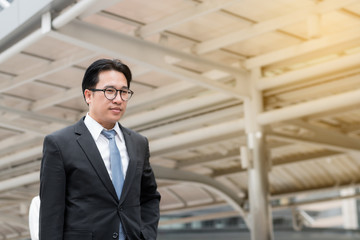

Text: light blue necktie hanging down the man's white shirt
xmin=101 ymin=130 xmax=125 ymax=240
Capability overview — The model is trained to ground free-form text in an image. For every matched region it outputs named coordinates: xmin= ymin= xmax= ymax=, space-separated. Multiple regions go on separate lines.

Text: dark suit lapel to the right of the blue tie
xmin=120 ymin=125 xmax=136 ymax=202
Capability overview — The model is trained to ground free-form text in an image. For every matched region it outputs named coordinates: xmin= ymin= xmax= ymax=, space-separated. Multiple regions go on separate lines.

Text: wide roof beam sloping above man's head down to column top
xmin=50 ymin=21 xmax=248 ymax=97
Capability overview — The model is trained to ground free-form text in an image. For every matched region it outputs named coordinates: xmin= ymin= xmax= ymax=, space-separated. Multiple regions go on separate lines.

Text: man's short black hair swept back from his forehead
xmin=81 ymin=59 xmax=131 ymax=98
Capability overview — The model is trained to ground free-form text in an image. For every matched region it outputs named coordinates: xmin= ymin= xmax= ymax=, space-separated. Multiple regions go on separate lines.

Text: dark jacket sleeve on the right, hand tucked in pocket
xmin=140 ymin=139 xmax=161 ymax=240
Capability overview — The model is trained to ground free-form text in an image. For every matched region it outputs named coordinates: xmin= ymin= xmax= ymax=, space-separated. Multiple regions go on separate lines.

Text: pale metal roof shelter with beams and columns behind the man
xmin=0 ymin=0 xmax=360 ymax=240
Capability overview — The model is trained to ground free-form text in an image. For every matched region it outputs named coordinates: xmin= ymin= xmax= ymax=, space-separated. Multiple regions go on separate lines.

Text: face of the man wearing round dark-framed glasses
xmin=85 ymin=70 xmax=128 ymax=129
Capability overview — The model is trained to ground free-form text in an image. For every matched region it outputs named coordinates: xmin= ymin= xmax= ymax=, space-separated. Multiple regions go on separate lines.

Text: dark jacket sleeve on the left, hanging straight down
xmin=39 ymin=135 xmax=66 ymax=240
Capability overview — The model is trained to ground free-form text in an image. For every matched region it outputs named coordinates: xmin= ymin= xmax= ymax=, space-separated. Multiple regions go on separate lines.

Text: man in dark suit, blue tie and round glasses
xmin=40 ymin=59 xmax=160 ymax=240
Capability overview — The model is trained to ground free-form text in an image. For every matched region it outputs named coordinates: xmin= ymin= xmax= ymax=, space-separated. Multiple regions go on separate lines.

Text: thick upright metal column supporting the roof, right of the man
xmin=244 ymin=68 xmax=274 ymax=240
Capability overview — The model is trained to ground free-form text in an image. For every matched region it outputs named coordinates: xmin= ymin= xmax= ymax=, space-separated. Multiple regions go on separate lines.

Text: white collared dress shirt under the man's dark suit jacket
xmin=84 ymin=114 xmax=129 ymax=179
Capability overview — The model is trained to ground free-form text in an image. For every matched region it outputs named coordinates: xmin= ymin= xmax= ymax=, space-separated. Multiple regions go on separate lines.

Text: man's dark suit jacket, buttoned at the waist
xmin=39 ymin=119 xmax=160 ymax=240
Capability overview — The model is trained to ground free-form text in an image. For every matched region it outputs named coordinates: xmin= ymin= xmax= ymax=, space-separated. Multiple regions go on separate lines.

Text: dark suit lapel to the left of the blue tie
xmin=75 ymin=119 xmax=117 ymax=199
